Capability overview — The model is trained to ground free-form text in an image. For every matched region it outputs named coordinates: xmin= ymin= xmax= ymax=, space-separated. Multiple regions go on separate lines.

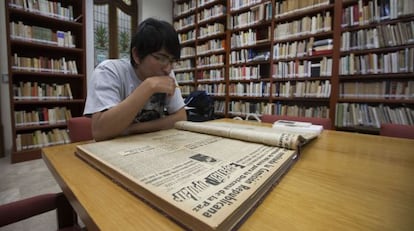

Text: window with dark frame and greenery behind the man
xmin=93 ymin=0 xmax=138 ymax=65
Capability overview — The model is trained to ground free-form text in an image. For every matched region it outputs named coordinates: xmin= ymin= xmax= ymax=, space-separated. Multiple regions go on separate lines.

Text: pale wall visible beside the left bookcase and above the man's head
xmin=0 ymin=0 xmax=172 ymax=155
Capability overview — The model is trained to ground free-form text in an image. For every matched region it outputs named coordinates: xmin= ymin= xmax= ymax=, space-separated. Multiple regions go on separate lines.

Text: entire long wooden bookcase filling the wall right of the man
xmin=173 ymin=0 xmax=414 ymax=133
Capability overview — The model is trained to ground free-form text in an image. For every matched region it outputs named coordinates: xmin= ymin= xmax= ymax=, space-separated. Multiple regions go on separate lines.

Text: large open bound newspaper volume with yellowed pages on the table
xmin=76 ymin=121 xmax=316 ymax=230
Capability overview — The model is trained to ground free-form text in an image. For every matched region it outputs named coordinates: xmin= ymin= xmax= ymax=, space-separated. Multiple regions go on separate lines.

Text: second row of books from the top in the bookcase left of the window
xmin=10 ymin=21 xmax=75 ymax=47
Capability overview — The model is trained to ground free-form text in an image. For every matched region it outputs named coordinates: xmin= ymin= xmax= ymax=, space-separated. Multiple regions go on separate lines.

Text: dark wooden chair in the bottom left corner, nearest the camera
xmin=0 ymin=192 xmax=81 ymax=231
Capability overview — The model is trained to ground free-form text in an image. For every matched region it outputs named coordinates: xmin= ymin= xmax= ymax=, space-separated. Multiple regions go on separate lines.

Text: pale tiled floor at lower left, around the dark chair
xmin=0 ymin=156 xmax=61 ymax=231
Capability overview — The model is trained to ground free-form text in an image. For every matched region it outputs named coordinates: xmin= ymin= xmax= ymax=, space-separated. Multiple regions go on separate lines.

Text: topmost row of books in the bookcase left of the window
xmin=9 ymin=0 xmax=74 ymax=21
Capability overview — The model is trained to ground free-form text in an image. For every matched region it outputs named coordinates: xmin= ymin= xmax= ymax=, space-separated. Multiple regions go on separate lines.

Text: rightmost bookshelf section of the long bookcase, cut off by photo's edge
xmin=335 ymin=0 xmax=414 ymax=134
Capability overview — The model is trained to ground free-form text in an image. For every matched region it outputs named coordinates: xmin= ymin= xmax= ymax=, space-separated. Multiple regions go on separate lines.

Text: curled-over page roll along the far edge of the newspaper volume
xmin=175 ymin=121 xmax=313 ymax=149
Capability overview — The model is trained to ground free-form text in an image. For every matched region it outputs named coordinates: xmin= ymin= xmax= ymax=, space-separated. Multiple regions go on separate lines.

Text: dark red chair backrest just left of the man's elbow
xmin=68 ymin=116 xmax=93 ymax=142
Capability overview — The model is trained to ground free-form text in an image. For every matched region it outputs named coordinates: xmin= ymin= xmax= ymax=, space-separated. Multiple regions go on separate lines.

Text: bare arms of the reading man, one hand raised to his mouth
xmin=92 ymin=76 xmax=179 ymax=141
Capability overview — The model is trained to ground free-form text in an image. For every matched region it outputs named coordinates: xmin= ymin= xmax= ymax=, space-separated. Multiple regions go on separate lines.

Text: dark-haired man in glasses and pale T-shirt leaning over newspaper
xmin=84 ymin=18 xmax=187 ymax=141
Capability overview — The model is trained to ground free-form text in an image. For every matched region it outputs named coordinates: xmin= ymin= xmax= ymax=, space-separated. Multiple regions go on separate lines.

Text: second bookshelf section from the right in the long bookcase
xmin=272 ymin=0 xmax=335 ymax=122
